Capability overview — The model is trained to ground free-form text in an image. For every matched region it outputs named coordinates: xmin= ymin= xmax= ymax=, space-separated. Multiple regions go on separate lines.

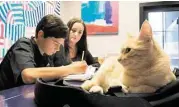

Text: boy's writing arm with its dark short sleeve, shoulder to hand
xmin=9 ymin=40 xmax=87 ymax=84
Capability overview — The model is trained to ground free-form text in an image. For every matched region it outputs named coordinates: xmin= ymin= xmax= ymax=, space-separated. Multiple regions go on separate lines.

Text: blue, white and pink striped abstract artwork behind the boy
xmin=0 ymin=1 xmax=60 ymax=62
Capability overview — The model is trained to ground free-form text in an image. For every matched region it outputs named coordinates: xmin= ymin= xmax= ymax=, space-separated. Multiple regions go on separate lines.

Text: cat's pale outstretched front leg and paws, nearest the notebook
xmin=81 ymin=58 xmax=117 ymax=93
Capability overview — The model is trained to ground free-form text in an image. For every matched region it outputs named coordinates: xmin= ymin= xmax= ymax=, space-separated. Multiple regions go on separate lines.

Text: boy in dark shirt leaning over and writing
xmin=0 ymin=15 xmax=87 ymax=90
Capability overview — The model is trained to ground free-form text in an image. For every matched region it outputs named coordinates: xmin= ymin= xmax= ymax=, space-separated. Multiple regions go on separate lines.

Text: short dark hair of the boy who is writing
xmin=35 ymin=14 xmax=68 ymax=38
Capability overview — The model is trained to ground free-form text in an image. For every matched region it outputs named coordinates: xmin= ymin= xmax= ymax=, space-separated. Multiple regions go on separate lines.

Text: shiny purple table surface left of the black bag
xmin=0 ymin=85 xmax=37 ymax=107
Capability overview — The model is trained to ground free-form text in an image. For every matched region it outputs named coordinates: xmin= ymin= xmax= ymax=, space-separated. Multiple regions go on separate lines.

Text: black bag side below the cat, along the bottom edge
xmin=34 ymin=79 xmax=151 ymax=107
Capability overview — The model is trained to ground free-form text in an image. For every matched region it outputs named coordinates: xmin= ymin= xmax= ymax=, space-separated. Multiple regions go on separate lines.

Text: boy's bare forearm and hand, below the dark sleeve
xmin=21 ymin=61 xmax=87 ymax=84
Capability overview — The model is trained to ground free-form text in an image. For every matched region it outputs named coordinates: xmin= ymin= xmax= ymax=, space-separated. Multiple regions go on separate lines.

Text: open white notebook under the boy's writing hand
xmin=63 ymin=66 xmax=97 ymax=81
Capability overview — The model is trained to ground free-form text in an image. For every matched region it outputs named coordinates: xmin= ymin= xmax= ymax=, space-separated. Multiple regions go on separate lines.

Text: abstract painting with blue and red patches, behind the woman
xmin=81 ymin=1 xmax=119 ymax=35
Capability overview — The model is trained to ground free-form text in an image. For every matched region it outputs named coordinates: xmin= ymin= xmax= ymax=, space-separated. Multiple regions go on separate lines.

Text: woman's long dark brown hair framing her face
xmin=64 ymin=18 xmax=88 ymax=55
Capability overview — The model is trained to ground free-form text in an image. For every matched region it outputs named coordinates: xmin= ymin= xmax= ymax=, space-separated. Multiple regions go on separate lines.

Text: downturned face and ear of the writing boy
xmin=37 ymin=31 xmax=65 ymax=55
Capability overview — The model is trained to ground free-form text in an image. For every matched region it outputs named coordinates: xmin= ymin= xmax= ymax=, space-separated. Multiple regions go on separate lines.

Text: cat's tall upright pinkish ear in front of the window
xmin=139 ymin=20 xmax=152 ymax=41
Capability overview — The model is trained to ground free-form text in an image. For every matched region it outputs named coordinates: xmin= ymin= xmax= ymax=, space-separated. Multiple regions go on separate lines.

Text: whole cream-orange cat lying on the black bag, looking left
xmin=81 ymin=21 xmax=176 ymax=93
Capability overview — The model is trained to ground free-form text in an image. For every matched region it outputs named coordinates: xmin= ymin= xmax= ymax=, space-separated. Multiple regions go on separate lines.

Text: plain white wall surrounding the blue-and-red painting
xmin=61 ymin=1 xmax=144 ymax=56
